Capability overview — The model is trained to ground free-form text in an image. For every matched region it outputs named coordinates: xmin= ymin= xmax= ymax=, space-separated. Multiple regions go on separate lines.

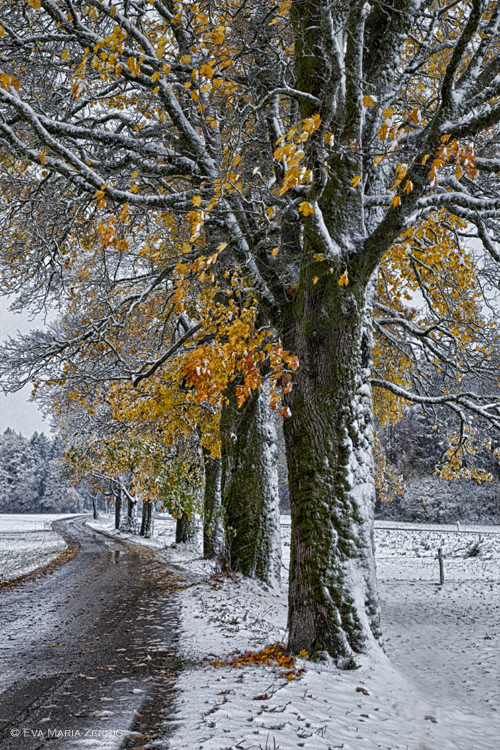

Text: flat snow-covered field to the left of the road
xmin=0 ymin=513 xmax=80 ymax=583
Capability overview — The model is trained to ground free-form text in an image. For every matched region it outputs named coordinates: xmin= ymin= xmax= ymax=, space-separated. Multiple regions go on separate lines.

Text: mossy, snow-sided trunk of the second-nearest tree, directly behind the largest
xmin=221 ymin=384 xmax=281 ymax=585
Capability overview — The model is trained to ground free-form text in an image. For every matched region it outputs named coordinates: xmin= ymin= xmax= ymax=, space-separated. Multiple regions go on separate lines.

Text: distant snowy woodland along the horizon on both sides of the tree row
xmin=0 ymin=418 xmax=500 ymax=523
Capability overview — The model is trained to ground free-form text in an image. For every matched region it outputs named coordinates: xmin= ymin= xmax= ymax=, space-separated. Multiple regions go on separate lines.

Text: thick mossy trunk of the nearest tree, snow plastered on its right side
xmin=284 ymin=266 xmax=379 ymax=668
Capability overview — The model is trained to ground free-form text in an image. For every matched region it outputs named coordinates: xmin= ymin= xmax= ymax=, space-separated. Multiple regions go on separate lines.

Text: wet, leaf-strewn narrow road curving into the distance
xmin=0 ymin=519 xmax=180 ymax=750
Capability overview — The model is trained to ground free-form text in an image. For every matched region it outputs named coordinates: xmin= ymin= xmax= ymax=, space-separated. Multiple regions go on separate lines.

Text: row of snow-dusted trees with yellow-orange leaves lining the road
xmin=0 ymin=0 xmax=500 ymax=667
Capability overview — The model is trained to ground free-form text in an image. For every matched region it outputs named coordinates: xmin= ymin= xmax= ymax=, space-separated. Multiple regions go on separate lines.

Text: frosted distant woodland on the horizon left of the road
xmin=0 ymin=428 xmax=86 ymax=513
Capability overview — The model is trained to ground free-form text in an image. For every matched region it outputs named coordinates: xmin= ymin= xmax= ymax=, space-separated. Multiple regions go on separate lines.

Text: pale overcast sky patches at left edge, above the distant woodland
xmin=0 ymin=297 xmax=50 ymax=437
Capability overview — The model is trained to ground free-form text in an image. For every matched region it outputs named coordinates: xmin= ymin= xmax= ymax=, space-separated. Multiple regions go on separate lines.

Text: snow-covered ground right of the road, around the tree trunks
xmin=91 ymin=517 xmax=500 ymax=750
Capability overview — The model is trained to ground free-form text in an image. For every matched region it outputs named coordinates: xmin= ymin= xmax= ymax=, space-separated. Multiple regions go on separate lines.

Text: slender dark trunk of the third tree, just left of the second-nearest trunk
xmin=203 ymin=448 xmax=224 ymax=560
